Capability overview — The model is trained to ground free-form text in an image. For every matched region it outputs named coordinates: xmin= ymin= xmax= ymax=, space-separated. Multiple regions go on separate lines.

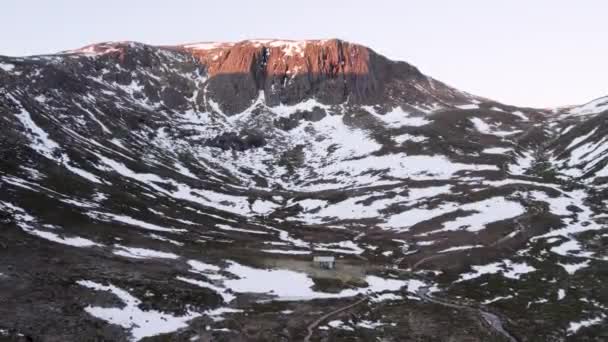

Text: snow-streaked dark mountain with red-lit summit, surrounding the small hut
xmin=0 ymin=39 xmax=608 ymax=341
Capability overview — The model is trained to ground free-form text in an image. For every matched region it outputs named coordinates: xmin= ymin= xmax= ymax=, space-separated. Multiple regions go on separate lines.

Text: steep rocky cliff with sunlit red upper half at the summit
xmin=177 ymin=39 xmax=466 ymax=114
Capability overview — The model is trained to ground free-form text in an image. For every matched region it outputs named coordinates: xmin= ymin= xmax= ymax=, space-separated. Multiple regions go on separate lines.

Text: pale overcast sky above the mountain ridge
xmin=0 ymin=0 xmax=608 ymax=107
